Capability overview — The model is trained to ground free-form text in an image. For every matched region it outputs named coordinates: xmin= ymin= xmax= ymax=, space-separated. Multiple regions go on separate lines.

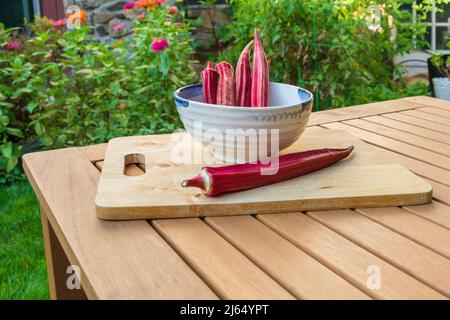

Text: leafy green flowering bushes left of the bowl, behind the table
xmin=0 ymin=6 xmax=195 ymax=183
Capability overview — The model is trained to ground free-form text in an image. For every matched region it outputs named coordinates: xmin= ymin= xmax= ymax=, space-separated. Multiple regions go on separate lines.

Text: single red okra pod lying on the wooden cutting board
xmin=181 ymin=146 xmax=354 ymax=197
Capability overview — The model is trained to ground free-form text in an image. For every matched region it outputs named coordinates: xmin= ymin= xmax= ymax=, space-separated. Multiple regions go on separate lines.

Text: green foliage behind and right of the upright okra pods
xmin=218 ymin=0 xmax=436 ymax=109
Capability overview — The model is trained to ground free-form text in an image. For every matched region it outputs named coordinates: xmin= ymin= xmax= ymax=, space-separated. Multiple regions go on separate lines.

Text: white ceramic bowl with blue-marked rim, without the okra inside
xmin=174 ymin=82 xmax=313 ymax=163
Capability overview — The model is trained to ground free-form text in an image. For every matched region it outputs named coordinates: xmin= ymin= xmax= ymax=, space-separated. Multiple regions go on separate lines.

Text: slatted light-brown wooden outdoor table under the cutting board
xmin=24 ymin=97 xmax=450 ymax=299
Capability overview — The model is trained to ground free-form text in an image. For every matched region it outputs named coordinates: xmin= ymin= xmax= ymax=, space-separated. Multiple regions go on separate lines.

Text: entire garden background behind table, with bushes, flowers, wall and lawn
xmin=0 ymin=0 xmax=450 ymax=299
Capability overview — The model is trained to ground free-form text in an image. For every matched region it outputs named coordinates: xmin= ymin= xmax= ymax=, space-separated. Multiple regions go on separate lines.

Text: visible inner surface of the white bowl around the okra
xmin=175 ymin=82 xmax=312 ymax=109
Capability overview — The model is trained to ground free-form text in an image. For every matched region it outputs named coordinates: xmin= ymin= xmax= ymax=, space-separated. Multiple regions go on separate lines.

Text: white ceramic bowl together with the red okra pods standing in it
xmin=174 ymin=30 xmax=313 ymax=163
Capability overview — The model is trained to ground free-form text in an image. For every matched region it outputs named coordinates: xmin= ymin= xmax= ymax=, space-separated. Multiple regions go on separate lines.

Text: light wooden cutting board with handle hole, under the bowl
xmin=95 ymin=128 xmax=432 ymax=220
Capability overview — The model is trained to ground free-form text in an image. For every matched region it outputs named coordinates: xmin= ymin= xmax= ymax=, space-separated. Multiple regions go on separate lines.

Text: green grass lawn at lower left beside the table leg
xmin=0 ymin=182 xmax=49 ymax=299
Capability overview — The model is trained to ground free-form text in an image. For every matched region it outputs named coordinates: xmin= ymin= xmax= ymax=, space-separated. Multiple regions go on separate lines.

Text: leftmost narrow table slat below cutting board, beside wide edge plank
xmin=152 ymin=218 xmax=294 ymax=299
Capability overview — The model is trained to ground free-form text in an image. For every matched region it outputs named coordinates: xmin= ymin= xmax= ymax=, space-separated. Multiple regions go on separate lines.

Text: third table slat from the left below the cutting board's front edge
xmin=257 ymin=213 xmax=444 ymax=299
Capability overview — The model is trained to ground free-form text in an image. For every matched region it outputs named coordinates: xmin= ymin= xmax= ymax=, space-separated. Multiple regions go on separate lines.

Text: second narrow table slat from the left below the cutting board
xmin=205 ymin=216 xmax=369 ymax=299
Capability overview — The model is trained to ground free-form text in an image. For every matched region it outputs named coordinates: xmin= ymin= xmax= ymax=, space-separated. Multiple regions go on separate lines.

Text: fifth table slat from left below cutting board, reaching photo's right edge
xmin=356 ymin=207 xmax=450 ymax=258
